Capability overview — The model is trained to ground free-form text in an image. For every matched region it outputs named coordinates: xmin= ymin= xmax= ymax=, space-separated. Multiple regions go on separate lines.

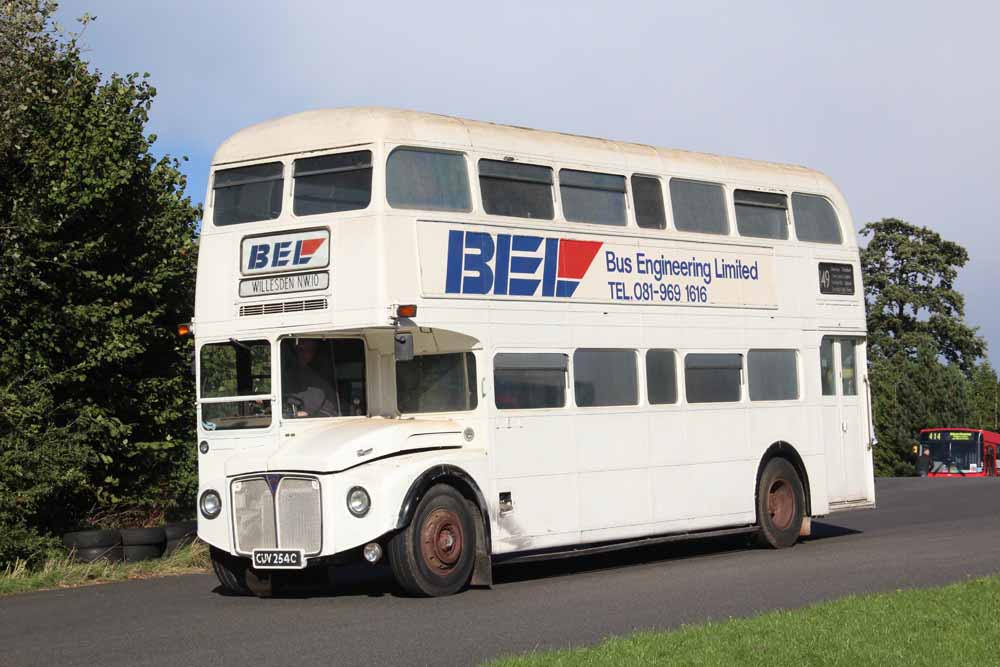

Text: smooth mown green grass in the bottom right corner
xmin=491 ymin=576 xmax=1000 ymax=667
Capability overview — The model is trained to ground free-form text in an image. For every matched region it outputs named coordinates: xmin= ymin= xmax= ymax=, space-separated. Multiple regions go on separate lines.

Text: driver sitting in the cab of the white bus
xmin=282 ymin=338 xmax=340 ymax=417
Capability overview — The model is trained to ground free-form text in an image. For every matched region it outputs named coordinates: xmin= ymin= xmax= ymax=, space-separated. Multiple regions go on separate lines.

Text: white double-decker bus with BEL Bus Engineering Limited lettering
xmin=193 ymin=109 xmax=875 ymax=595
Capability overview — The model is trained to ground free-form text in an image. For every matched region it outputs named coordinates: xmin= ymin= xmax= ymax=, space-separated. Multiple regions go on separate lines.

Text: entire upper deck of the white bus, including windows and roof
xmin=196 ymin=109 xmax=864 ymax=342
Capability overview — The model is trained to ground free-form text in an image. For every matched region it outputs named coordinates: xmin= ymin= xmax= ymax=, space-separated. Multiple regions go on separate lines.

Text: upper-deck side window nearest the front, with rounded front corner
xmin=386 ymin=148 xmax=472 ymax=211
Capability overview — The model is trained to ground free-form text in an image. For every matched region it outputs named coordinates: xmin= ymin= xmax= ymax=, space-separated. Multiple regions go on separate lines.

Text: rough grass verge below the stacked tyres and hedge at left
xmin=0 ymin=542 xmax=211 ymax=596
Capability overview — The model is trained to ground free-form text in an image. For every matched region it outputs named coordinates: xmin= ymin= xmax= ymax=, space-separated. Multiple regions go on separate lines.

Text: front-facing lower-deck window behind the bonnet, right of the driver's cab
xmin=396 ymin=352 xmax=477 ymax=413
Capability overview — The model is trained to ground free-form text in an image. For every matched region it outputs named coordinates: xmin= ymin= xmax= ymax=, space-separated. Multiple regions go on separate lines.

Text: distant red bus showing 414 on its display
xmin=917 ymin=428 xmax=1000 ymax=477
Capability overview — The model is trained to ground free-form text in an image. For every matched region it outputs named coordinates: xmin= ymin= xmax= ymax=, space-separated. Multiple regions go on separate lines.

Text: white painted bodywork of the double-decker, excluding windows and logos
xmin=195 ymin=109 xmax=874 ymax=556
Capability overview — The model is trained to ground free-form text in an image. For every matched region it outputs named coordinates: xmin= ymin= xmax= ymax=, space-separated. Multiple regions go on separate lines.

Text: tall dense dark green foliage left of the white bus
xmin=0 ymin=0 xmax=200 ymax=563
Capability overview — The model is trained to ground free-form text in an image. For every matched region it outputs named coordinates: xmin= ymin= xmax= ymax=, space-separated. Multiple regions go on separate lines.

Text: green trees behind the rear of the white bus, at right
xmin=861 ymin=218 xmax=997 ymax=475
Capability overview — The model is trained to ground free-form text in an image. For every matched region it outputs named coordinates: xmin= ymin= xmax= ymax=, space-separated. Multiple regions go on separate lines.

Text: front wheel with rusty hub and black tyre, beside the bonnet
xmin=388 ymin=484 xmax=476 ymax=597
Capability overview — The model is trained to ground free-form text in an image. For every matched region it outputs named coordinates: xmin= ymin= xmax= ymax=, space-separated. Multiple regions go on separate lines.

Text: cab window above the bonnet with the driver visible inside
xmin=281 ymin=338 xmax=368 ymax=419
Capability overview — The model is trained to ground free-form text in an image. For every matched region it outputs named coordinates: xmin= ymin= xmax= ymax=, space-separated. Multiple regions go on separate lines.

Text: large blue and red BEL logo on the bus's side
xmin=445 ymin=229 xmax=603 ymax=297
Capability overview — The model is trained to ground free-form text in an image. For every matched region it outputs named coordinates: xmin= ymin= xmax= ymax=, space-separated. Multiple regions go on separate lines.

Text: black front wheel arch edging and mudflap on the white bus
xmin=396 ymin=464 xmax=493 ymax=586
